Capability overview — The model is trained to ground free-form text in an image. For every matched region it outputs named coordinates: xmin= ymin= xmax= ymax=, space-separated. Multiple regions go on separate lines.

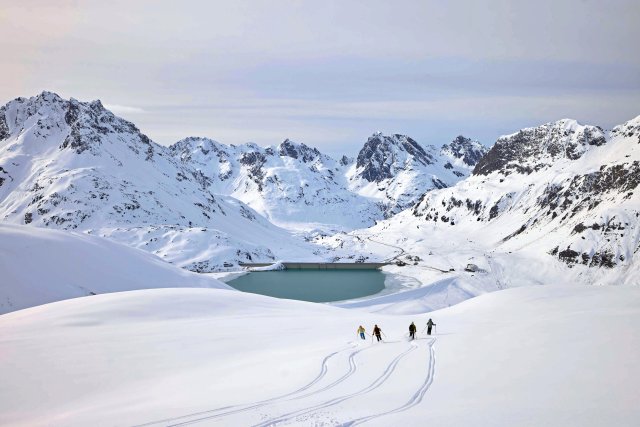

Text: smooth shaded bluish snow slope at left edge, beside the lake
xmin=0 ymin=224 xmax=228 ymax=313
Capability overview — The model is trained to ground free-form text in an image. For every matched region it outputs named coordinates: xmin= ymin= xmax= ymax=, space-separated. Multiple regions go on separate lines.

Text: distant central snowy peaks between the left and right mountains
xmin=171 ymin=133 xmax=486 ymax=230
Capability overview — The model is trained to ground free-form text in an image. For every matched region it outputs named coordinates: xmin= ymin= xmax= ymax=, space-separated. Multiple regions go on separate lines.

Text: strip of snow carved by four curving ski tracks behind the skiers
xmin=137 ymin=336 xmax=436 ymax=427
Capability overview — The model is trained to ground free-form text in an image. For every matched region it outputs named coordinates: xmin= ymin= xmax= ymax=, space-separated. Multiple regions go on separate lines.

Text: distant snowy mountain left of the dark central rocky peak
xmin=170 ymin=137 xmax=382 ymax=229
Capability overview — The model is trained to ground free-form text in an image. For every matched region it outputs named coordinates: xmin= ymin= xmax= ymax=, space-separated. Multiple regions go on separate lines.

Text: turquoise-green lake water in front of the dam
xmin=227 ymin=270 xmax=384 ymax=302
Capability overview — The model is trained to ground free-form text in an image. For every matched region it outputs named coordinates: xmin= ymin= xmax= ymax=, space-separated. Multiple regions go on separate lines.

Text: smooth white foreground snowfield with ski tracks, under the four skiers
xmin=0 ymin=286 xmax=640 ymax=426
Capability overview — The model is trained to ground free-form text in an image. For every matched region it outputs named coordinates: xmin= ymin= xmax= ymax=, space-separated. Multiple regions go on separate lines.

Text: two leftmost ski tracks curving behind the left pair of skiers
xmin=133 ymin=344 xmax=360 ymax=427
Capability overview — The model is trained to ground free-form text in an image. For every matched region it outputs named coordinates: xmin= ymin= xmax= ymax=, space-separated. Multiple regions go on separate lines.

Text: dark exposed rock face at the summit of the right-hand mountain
xmin=473 ymin=119 xmax=606 ymax=175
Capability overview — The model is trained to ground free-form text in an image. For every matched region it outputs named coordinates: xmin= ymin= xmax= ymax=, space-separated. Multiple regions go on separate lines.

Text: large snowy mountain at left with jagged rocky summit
xmin=0 ymin=92 xmax=320 ymax=271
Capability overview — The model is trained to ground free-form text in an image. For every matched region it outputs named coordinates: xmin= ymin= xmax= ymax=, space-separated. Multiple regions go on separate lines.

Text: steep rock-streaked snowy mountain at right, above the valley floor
xmin=411 ymin=118 xmax=640 ymax=274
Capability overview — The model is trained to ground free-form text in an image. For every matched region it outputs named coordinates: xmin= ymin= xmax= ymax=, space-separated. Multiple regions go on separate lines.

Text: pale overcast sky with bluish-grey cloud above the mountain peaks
xmin=0 ymin=0 xmax=640 ymax=156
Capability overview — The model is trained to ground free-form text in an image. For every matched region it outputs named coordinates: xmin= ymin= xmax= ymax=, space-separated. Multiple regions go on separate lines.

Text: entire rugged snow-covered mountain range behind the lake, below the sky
xmin=0 ymin=92 xmax=640 ymax=278
